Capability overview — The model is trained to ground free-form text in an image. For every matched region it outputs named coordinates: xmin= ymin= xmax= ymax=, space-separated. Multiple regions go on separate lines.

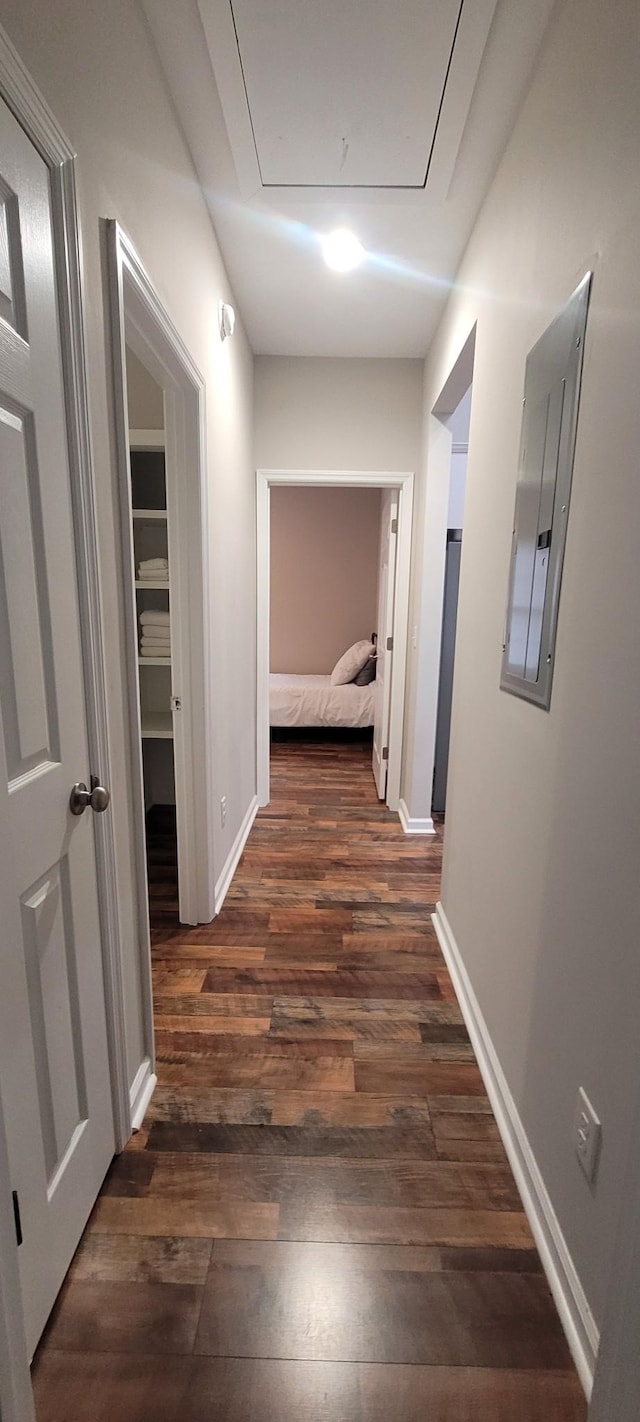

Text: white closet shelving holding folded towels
xmin=129 ymin=429 xmax=174 ymax=741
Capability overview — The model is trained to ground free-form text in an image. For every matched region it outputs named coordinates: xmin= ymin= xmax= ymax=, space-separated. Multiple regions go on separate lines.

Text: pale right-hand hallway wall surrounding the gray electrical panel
xmin=410 ymin=0 xmax=640 ymax=1342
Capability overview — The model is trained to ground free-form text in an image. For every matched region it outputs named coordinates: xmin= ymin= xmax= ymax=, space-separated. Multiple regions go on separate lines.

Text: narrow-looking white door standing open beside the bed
xmin=373 ymin=489 xmax=398 ymax=799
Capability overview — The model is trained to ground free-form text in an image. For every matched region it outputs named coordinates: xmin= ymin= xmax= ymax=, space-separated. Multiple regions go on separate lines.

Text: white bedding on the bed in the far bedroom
xmin=269 ymin=671 xmax=375 ymax=727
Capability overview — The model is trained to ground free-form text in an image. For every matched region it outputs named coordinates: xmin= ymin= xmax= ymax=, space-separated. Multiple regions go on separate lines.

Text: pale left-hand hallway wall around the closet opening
xmin=0 ymin=0 xmax=256 ymax=1103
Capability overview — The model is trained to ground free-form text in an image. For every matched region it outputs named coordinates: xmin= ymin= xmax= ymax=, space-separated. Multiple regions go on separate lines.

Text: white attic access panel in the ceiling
xmin=220 ymin=0 xmax=475 ymax=189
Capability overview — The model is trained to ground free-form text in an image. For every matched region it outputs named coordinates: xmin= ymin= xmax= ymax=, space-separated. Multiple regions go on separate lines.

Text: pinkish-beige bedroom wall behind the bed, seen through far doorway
xmin=270 ymin=485 xmax=380 ymax=673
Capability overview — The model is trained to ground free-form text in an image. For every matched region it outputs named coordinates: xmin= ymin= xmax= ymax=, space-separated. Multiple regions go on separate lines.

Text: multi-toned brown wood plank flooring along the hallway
xmin=34 ymin=742 xmax=586 ymax=1422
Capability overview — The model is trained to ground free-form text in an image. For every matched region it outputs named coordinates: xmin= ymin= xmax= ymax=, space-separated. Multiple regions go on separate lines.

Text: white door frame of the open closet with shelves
xmin=105 ymin=222 xmax=215 ymax=944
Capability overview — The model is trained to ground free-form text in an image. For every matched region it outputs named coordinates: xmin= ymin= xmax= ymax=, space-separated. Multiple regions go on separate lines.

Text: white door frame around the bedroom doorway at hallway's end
xmin=256 ymin=469 xmax=414 ymax=811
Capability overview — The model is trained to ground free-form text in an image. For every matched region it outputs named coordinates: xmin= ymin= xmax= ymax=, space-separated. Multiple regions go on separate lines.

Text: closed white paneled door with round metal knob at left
xmin=0 ymin=94 xmax=114 ymax=1352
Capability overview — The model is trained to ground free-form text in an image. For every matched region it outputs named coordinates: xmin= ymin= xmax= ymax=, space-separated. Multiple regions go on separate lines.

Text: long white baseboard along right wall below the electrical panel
xmin=432 ymin=903 xmax=600 ymax=1398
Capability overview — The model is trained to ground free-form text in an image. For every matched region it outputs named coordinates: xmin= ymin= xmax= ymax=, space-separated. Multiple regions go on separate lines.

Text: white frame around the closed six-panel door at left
xmin=0 ymin=27 xmax=123 ymax=1422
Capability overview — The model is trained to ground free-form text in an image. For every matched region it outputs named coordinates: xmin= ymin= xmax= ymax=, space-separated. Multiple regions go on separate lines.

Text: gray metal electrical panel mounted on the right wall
xmin=501 ymin=273 xmax=592 ymax=710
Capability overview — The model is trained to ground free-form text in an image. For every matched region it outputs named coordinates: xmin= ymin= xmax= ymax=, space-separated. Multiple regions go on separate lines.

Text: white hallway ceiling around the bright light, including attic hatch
xmin=142 ymin=0 xmax=553 ymax=357
